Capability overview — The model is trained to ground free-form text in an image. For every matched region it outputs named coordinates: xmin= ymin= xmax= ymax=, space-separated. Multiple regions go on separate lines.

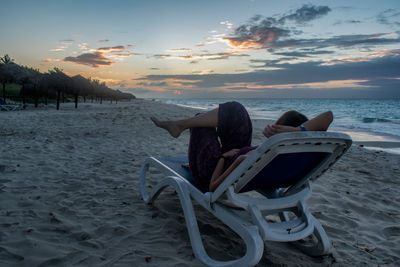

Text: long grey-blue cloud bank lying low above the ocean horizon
xmin=137 ymin=51 xmax=400 ymax=97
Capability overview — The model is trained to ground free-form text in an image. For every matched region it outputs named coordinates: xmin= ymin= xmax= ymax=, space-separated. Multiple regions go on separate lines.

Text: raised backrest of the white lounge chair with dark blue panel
xmin=211 ymin=132 xmax=352 ymax=201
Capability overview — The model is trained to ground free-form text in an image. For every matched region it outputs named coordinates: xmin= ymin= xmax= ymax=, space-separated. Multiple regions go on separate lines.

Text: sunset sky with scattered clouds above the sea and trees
xmin=0 ymin=0 xmax=400 ymax=98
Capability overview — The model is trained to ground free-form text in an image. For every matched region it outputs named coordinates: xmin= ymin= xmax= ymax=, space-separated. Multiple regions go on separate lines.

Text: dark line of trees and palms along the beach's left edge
xmin=0 ymin=55 xmax=135 ymax=109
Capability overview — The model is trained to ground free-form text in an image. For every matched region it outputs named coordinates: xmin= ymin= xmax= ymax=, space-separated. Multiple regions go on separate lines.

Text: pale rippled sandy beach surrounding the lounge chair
xmin=0 ymin=99 xmax=400 ymax=266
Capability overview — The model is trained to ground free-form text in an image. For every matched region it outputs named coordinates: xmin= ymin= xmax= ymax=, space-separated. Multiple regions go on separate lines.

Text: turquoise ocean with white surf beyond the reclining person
xmin=157 ymin=98 xmax=400 ymax=141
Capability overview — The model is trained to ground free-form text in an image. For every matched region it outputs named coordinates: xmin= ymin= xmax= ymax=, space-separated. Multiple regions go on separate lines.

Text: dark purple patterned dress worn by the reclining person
xmin=188 ymin=102 xmax=256 ymax=192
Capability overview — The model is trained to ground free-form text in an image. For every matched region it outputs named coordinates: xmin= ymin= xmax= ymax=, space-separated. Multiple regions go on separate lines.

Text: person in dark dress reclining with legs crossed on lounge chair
xmin=151 ymin=102 xmax=333 ymax=192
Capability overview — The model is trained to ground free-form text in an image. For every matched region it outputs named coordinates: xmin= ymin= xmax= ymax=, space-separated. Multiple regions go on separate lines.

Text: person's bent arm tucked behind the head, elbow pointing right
xmin=263 ymin=111 xmax=333 ymax=137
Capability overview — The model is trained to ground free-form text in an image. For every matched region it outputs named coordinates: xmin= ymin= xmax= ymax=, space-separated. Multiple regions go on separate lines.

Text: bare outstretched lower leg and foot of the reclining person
xmin=150 ymin=108 xmax=218 ymax=138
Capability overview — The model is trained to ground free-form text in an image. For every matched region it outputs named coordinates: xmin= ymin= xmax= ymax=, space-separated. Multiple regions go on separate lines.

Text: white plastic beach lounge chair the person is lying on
xmin=140 ymin=132 xmax=352 ymax=266
